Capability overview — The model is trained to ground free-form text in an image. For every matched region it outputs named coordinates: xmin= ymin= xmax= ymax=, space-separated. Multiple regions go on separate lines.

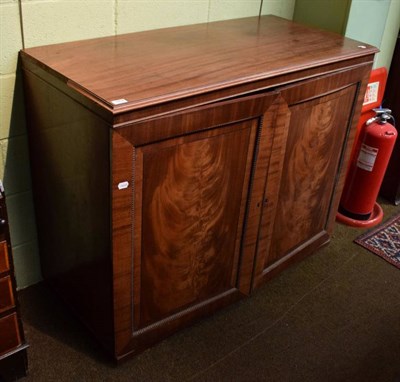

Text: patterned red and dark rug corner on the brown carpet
xmin=354 ymin=214 xmax=400 ymax=269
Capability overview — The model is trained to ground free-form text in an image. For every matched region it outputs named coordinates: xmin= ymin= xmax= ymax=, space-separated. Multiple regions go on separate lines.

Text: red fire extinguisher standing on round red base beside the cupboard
xmin=337 ymin=108 xmax=397 ymax=227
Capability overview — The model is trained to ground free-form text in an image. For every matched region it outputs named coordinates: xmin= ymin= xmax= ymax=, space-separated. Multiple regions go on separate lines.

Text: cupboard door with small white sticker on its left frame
xmin=109 ymin=94 xmax=276 ymax=358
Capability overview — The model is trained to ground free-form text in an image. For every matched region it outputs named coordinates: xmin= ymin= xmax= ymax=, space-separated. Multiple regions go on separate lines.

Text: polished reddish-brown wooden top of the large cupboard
xmin=21 ymin=16 xmax=377 ymax=112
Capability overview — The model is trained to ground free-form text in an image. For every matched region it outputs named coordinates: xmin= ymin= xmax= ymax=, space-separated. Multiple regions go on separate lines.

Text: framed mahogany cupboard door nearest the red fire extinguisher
xmin=254 ymin=69 xmax=365 ymax=286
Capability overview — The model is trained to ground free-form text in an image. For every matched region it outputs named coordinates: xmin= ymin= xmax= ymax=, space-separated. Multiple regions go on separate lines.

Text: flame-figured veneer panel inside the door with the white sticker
xmin=140 ymin=122 xmax=252 ymax=326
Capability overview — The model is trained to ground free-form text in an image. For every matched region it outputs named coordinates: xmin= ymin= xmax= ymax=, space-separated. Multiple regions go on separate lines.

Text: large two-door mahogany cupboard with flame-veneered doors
xmin=21 ymin=16 xmax=377 ymax=360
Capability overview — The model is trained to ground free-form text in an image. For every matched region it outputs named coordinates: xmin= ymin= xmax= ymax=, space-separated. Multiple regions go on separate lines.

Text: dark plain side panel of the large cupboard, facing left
xmin=24 ymin=71 xmax=113 ymax=347
